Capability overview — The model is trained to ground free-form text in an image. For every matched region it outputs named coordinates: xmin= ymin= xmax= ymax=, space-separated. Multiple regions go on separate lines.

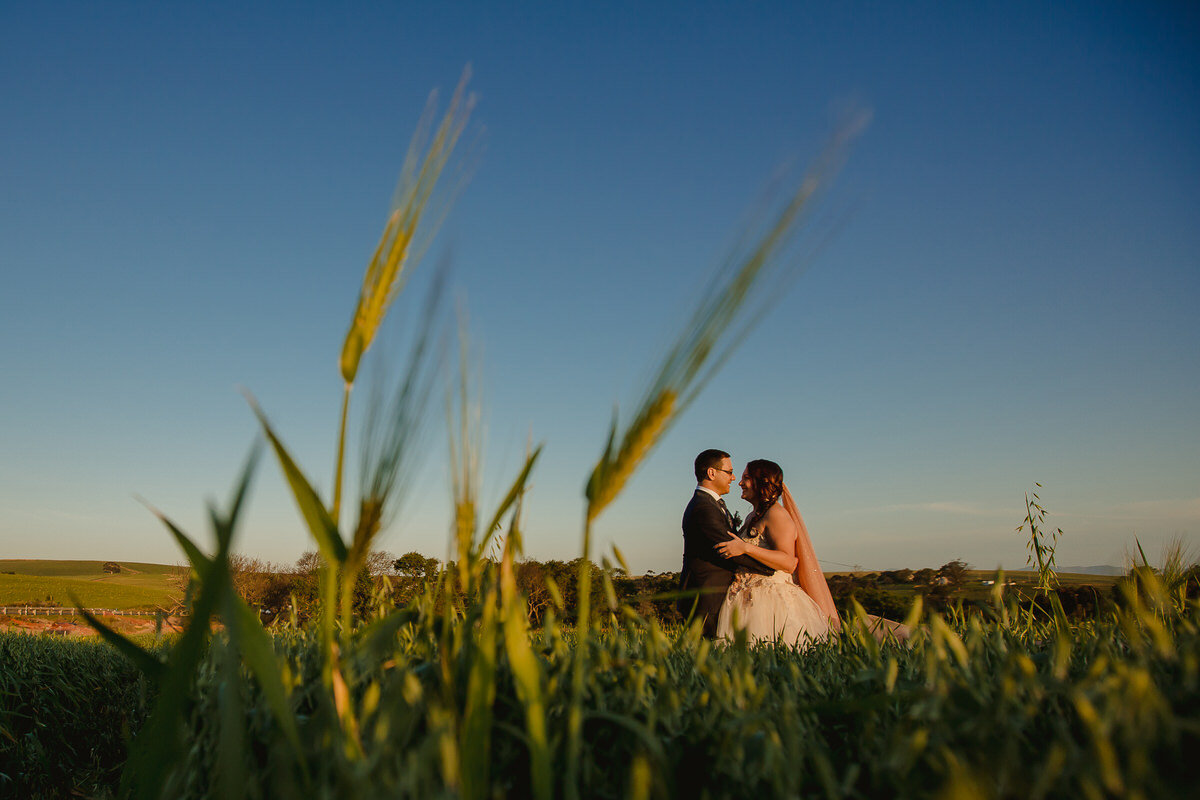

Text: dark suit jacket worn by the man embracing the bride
xmin=678 ymin=488 xmax=774 ymax=638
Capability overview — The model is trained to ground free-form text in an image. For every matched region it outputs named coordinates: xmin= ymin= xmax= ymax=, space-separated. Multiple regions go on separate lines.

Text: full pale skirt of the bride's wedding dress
xmin=716 ymin=570 xmax=829 ymax=644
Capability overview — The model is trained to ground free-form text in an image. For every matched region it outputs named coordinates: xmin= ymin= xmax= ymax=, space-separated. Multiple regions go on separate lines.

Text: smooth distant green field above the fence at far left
xmin=0 ymin=573 xmax=179 ymax=608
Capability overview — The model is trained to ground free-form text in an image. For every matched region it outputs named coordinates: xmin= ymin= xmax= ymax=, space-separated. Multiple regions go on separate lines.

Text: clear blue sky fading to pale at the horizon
xmin=0 ymin=2 xmax=1200 ymax=570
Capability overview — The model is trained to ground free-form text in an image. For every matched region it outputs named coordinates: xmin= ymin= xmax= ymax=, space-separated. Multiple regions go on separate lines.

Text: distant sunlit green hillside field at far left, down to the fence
xmin=0 ymin=559 xmax=180 ymax=608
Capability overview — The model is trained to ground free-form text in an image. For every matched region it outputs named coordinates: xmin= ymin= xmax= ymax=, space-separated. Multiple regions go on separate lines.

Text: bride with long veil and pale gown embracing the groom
xmin=716 ymin=459 xmax=841 ymax=644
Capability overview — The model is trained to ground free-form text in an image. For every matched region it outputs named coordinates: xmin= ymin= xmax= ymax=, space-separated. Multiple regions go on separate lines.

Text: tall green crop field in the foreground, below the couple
xmin=0 ymin=584 xmax=1200 ymax=798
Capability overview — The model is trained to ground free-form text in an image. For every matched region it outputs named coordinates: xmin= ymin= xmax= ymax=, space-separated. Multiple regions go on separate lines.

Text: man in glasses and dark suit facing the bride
xmin=678 ymin=450 xmax=773 ymax=639
